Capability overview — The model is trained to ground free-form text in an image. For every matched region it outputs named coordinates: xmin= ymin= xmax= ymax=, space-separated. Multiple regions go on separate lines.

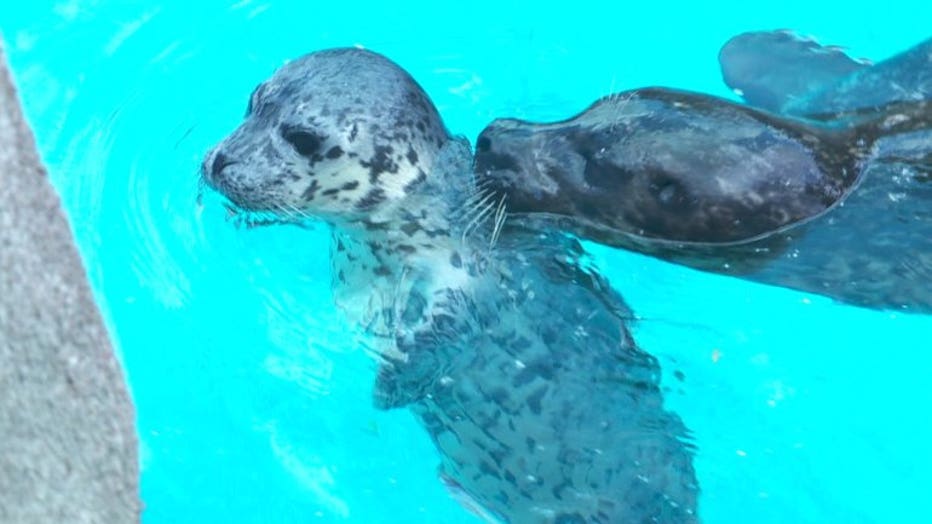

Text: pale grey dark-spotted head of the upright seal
xmin=202 ymin=49 xmax=449 ymax=217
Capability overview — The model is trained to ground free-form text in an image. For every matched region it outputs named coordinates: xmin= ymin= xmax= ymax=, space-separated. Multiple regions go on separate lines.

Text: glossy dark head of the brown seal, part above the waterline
xmin=476 ymin=88 xmax=863 ymax=243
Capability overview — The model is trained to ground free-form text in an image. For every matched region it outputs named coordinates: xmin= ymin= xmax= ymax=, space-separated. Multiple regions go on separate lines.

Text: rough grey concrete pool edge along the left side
xmin=0 ymin=42 xmax=141 ymax=523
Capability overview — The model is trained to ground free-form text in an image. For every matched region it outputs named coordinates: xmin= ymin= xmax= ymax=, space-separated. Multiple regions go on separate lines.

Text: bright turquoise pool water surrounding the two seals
xmin=0 ymin=0 xmax=932 ymax=523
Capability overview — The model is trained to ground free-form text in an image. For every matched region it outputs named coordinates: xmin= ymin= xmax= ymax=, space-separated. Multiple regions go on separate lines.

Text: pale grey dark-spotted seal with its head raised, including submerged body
xmin=203 ymin=49 xmax=698 ymax=524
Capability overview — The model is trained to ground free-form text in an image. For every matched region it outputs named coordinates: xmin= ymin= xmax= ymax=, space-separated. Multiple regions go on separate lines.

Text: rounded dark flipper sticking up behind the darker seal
xmin=718 ymin=30 xmax=869 ymax=113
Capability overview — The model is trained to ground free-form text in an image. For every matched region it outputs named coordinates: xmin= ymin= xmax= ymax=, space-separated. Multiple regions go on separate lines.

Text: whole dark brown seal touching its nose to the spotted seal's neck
xmin=476 ymin=39 xmax=932 ymax=311
